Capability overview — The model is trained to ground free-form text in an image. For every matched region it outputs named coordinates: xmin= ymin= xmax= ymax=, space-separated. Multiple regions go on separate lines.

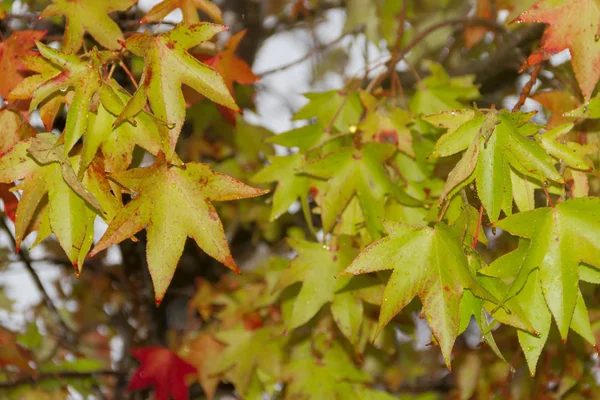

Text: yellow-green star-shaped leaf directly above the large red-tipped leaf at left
xmin=122 ymin=23 xmax=239 ymax=153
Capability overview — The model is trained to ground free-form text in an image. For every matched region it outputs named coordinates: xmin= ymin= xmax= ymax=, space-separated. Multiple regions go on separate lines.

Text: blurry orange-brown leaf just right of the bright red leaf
xmin=182 ymin=333 xmax=225 ymax=400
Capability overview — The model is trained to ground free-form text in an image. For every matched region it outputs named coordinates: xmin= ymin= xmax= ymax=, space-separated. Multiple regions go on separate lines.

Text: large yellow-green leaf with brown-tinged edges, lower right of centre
xmin=343 ymin=221 xmax=497 ymax=369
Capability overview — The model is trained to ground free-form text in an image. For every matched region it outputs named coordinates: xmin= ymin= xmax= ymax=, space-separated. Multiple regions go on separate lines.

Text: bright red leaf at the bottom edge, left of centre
xmin=127 ymin=346 xmax=196 ymax=400
